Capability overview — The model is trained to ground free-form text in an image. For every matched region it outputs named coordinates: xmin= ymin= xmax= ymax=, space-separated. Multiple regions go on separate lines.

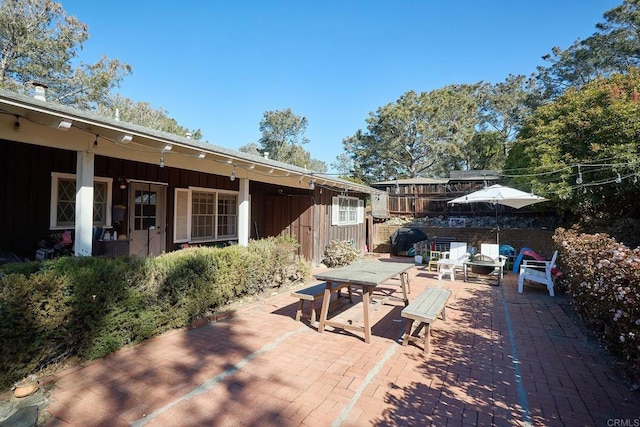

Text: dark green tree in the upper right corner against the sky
xmin=536 ymin=0 xmax=640 ymax=99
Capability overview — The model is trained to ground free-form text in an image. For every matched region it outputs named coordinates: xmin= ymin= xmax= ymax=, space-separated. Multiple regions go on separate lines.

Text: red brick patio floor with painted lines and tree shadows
xmin=42 ymin=258 xmax=640 ymax=426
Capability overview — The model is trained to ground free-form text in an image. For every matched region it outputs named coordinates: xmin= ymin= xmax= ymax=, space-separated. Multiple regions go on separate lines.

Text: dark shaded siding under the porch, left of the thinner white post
xmin=0 ymin=140 xmax=238 ymax=259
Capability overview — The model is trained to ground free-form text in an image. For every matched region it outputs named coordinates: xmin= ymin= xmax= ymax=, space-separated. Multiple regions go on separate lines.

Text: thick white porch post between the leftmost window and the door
xmin=74 ymin=151 xmax=95 ymax=256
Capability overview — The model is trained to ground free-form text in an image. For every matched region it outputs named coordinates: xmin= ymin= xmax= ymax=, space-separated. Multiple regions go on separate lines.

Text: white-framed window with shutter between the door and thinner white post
xmin=173 ymin=188 xmax=238 ymax=243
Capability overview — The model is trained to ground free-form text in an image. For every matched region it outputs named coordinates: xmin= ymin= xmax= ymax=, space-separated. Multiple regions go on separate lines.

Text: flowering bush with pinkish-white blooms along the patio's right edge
xmin=554 ymin=228 xmax=640 ymax=381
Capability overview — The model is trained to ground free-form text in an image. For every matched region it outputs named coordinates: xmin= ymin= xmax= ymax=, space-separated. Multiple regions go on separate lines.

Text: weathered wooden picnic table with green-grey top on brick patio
xmin=314 ymin=260 xmax=413 ymax=343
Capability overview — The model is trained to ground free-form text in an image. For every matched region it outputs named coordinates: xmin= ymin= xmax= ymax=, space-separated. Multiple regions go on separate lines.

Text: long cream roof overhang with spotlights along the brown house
xmin=0 ymin=89 xmax=381 ymax=198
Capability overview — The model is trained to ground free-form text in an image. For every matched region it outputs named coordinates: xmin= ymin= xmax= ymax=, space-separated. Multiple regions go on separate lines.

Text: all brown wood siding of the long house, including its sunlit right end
xmin=0 ymin=140 xmax=367 ymax=265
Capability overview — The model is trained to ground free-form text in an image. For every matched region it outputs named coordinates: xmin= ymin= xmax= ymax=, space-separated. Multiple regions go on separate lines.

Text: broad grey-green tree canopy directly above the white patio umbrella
xmin=334 ymin=83 xmax=533 ymax=183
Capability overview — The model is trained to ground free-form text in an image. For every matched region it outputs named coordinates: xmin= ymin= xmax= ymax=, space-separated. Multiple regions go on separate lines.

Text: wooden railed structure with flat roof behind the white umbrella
xmin=372 ymin=170 xmax=499 ymax=218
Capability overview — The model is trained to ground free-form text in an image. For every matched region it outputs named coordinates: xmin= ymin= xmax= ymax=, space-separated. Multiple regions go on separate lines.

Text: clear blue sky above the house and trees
xmin=61 ymin=0 xmax=622 ymax=169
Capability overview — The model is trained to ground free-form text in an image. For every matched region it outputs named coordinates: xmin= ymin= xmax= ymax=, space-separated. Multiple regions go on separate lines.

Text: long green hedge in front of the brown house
xmin=0 ymin=238 xmax=311 ymax=390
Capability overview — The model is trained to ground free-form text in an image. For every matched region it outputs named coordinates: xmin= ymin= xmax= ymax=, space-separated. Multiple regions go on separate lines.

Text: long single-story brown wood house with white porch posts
xmin=0 ymin=90 xmax=386 ymax=265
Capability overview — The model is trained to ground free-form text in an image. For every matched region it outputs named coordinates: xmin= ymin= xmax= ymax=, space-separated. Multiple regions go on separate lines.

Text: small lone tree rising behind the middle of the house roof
xmin=239 ymin=108 xmax=327 ymax=172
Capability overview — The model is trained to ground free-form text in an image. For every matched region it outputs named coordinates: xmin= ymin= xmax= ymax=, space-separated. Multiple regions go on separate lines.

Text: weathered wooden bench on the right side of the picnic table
xmin=401 ymin=288 xmax=451 ymax=353
